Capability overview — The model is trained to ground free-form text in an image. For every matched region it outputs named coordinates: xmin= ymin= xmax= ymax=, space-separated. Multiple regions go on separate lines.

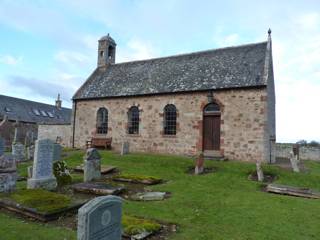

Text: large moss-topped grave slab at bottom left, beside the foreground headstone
xmin=0 ymin=189 xmax=85 ymax=222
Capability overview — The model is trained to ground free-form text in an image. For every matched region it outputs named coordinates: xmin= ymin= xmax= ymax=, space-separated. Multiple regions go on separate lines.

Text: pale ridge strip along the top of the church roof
xmin=111 ymin=41 xmax=268 ymax=66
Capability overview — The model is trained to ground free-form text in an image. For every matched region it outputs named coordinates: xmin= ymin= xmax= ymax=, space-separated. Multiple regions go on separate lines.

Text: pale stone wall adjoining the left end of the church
xmin=38 ymin=124 xmax=72 ymax=147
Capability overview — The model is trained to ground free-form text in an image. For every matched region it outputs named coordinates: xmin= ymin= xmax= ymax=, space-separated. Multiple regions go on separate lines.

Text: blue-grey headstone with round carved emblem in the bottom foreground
xmin=77 ymin=196 xmax=122 ymax=240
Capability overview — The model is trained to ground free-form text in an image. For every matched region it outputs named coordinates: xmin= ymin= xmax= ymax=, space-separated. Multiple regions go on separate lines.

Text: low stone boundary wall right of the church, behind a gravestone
xmin=276 ymin=143 xmax=320 ymax=161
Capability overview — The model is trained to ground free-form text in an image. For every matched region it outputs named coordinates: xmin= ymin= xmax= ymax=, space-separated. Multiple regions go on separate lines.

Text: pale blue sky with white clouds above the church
xmin=0 ymin=0 xmax=320 ymax=142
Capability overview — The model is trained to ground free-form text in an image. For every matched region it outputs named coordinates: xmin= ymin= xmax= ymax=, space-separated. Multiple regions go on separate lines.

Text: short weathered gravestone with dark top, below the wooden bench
xmin=83 ymin=148 xmax=101 ymax=182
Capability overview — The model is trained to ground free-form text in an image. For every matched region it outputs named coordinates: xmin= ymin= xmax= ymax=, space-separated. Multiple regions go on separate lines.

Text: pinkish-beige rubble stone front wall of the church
xmin=72 ymin=87 xmax=272 ymax=162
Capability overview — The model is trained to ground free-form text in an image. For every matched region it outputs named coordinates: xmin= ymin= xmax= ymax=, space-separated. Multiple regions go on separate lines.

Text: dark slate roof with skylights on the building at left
xmin=0 ymin=95 xmax=71 ymax=124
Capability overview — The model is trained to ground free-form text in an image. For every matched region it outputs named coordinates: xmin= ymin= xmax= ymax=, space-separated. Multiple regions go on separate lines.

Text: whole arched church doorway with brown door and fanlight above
xmin=203 ymin=103 xmax=221 ymax=151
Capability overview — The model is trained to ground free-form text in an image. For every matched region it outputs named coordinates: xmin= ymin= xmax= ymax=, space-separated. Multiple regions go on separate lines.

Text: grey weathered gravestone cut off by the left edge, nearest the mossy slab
xmin=0 ymin=155 xmax=17 ymax=192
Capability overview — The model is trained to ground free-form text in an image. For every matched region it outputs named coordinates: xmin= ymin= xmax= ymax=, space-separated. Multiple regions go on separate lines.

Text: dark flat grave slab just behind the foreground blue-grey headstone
xmin=72 ymin=183 xmax=124 ymax=195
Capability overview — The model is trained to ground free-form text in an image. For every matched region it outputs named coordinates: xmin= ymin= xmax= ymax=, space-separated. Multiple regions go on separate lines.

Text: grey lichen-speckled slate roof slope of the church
xmin=73 ymin=42 xmax=268 ymax=100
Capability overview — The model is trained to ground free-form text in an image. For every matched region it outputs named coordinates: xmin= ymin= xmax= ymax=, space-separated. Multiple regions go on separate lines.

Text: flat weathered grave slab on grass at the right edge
xmin=266 ymin=184 xmax=320 ymax=199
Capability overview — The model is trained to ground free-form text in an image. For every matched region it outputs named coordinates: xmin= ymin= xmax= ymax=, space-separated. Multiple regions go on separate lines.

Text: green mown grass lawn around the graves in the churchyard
xmin=0 ymin=151 xmax=320 ymax=240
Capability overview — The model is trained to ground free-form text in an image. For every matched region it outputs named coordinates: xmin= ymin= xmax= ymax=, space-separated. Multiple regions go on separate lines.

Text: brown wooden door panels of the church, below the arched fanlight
xmin=203 ymin=115 xmax=220 ymax=150
